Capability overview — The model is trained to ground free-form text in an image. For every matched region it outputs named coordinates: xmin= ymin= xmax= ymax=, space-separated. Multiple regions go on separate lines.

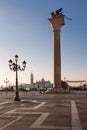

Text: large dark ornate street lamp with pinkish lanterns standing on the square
xmin=8 ymin=55 xmax=26 ymax=101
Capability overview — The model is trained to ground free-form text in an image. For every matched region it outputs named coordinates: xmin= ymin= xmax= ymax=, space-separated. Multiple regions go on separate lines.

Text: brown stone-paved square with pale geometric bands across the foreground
xmin=0 ymin=92 xmax=87 ymax=130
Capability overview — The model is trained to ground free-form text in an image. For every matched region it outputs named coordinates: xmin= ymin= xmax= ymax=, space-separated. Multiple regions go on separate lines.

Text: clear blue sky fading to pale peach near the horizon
xmin=0 ymin=0 xmax=87 ymax=86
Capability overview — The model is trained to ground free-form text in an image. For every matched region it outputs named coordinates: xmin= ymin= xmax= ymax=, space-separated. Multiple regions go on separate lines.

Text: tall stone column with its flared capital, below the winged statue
xmin=48 ymin=15 xmax=64 ymax=89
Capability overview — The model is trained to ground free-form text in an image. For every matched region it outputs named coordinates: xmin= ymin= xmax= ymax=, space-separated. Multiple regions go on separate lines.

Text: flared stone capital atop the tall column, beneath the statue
xmin=48 ymin=15 xmax=64 ymax=30
